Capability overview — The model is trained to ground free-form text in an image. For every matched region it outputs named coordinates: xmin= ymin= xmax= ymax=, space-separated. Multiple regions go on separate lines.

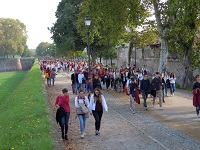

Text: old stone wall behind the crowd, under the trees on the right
xmin=118 ymin=44 xmax=200 ymax=85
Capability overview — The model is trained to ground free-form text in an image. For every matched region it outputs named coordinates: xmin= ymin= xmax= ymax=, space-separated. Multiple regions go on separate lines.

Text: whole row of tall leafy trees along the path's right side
xmin=49 ymin=0 xmax=200 ymax=87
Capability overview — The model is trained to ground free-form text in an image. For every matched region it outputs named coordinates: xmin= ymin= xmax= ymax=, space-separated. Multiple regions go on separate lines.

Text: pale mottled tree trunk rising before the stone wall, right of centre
xmin=152 ymin=0 xmax=168 ymax=73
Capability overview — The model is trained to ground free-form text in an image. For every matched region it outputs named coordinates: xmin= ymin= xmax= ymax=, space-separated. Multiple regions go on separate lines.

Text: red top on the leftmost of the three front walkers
xmin=55 ymin=95 xmax=70 ymax=112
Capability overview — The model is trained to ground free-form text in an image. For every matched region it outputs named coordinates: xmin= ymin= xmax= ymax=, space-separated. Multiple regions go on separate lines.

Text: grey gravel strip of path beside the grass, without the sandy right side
xmin=44 ymin=73 xmax=200 ymax=150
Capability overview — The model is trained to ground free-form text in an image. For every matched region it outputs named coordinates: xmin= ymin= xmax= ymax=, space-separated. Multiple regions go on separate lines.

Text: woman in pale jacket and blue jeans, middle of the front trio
xmin=75 ymin=90 xmax=89 ymax=138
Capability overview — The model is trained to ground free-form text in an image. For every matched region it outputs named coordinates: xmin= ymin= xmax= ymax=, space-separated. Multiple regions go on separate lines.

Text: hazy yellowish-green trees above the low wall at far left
xmin=0 ymin=18 xmax=33 ymax=58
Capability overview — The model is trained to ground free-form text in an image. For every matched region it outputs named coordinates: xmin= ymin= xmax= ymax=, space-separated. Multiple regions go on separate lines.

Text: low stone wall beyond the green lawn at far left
xmin=0 ymin=58 xmax=34 ymax=72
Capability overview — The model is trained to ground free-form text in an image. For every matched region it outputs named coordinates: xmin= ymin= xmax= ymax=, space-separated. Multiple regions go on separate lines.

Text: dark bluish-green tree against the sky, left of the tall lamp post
xmin=50 ymin=0 xmax=86 ymax=56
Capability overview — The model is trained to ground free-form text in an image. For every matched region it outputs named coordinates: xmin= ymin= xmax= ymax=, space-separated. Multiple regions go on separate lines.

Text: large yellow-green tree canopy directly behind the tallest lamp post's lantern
xmin=77 ymin=0 xmax=148 ymax=62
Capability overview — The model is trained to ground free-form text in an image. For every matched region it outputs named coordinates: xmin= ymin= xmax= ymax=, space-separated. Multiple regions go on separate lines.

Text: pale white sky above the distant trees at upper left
xmin=0 ymin=0 xmax=61 ymax=49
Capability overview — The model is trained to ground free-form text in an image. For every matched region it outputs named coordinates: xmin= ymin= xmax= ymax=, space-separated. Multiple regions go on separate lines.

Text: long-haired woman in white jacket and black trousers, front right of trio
xmin=89 ymin=88 xmax=108 ymax=135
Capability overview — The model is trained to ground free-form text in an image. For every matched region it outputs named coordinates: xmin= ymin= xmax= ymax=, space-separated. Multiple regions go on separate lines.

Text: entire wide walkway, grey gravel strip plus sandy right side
xmin=47 ymin=73 xmax=200 ymax=150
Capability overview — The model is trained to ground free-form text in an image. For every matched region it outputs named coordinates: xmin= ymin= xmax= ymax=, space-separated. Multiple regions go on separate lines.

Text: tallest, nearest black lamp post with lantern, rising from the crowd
xmin=85 ymin=16 xmax=91 ymax=77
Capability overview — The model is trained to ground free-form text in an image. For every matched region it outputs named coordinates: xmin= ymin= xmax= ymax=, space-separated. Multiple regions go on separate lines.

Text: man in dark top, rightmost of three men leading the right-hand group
xmin=151 ymin=72 xmax=163 ymax=110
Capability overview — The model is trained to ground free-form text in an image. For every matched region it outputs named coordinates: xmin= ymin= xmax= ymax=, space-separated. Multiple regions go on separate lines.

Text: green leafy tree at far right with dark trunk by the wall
xmin=166 ymin=0 xmax=200 ymax=88
